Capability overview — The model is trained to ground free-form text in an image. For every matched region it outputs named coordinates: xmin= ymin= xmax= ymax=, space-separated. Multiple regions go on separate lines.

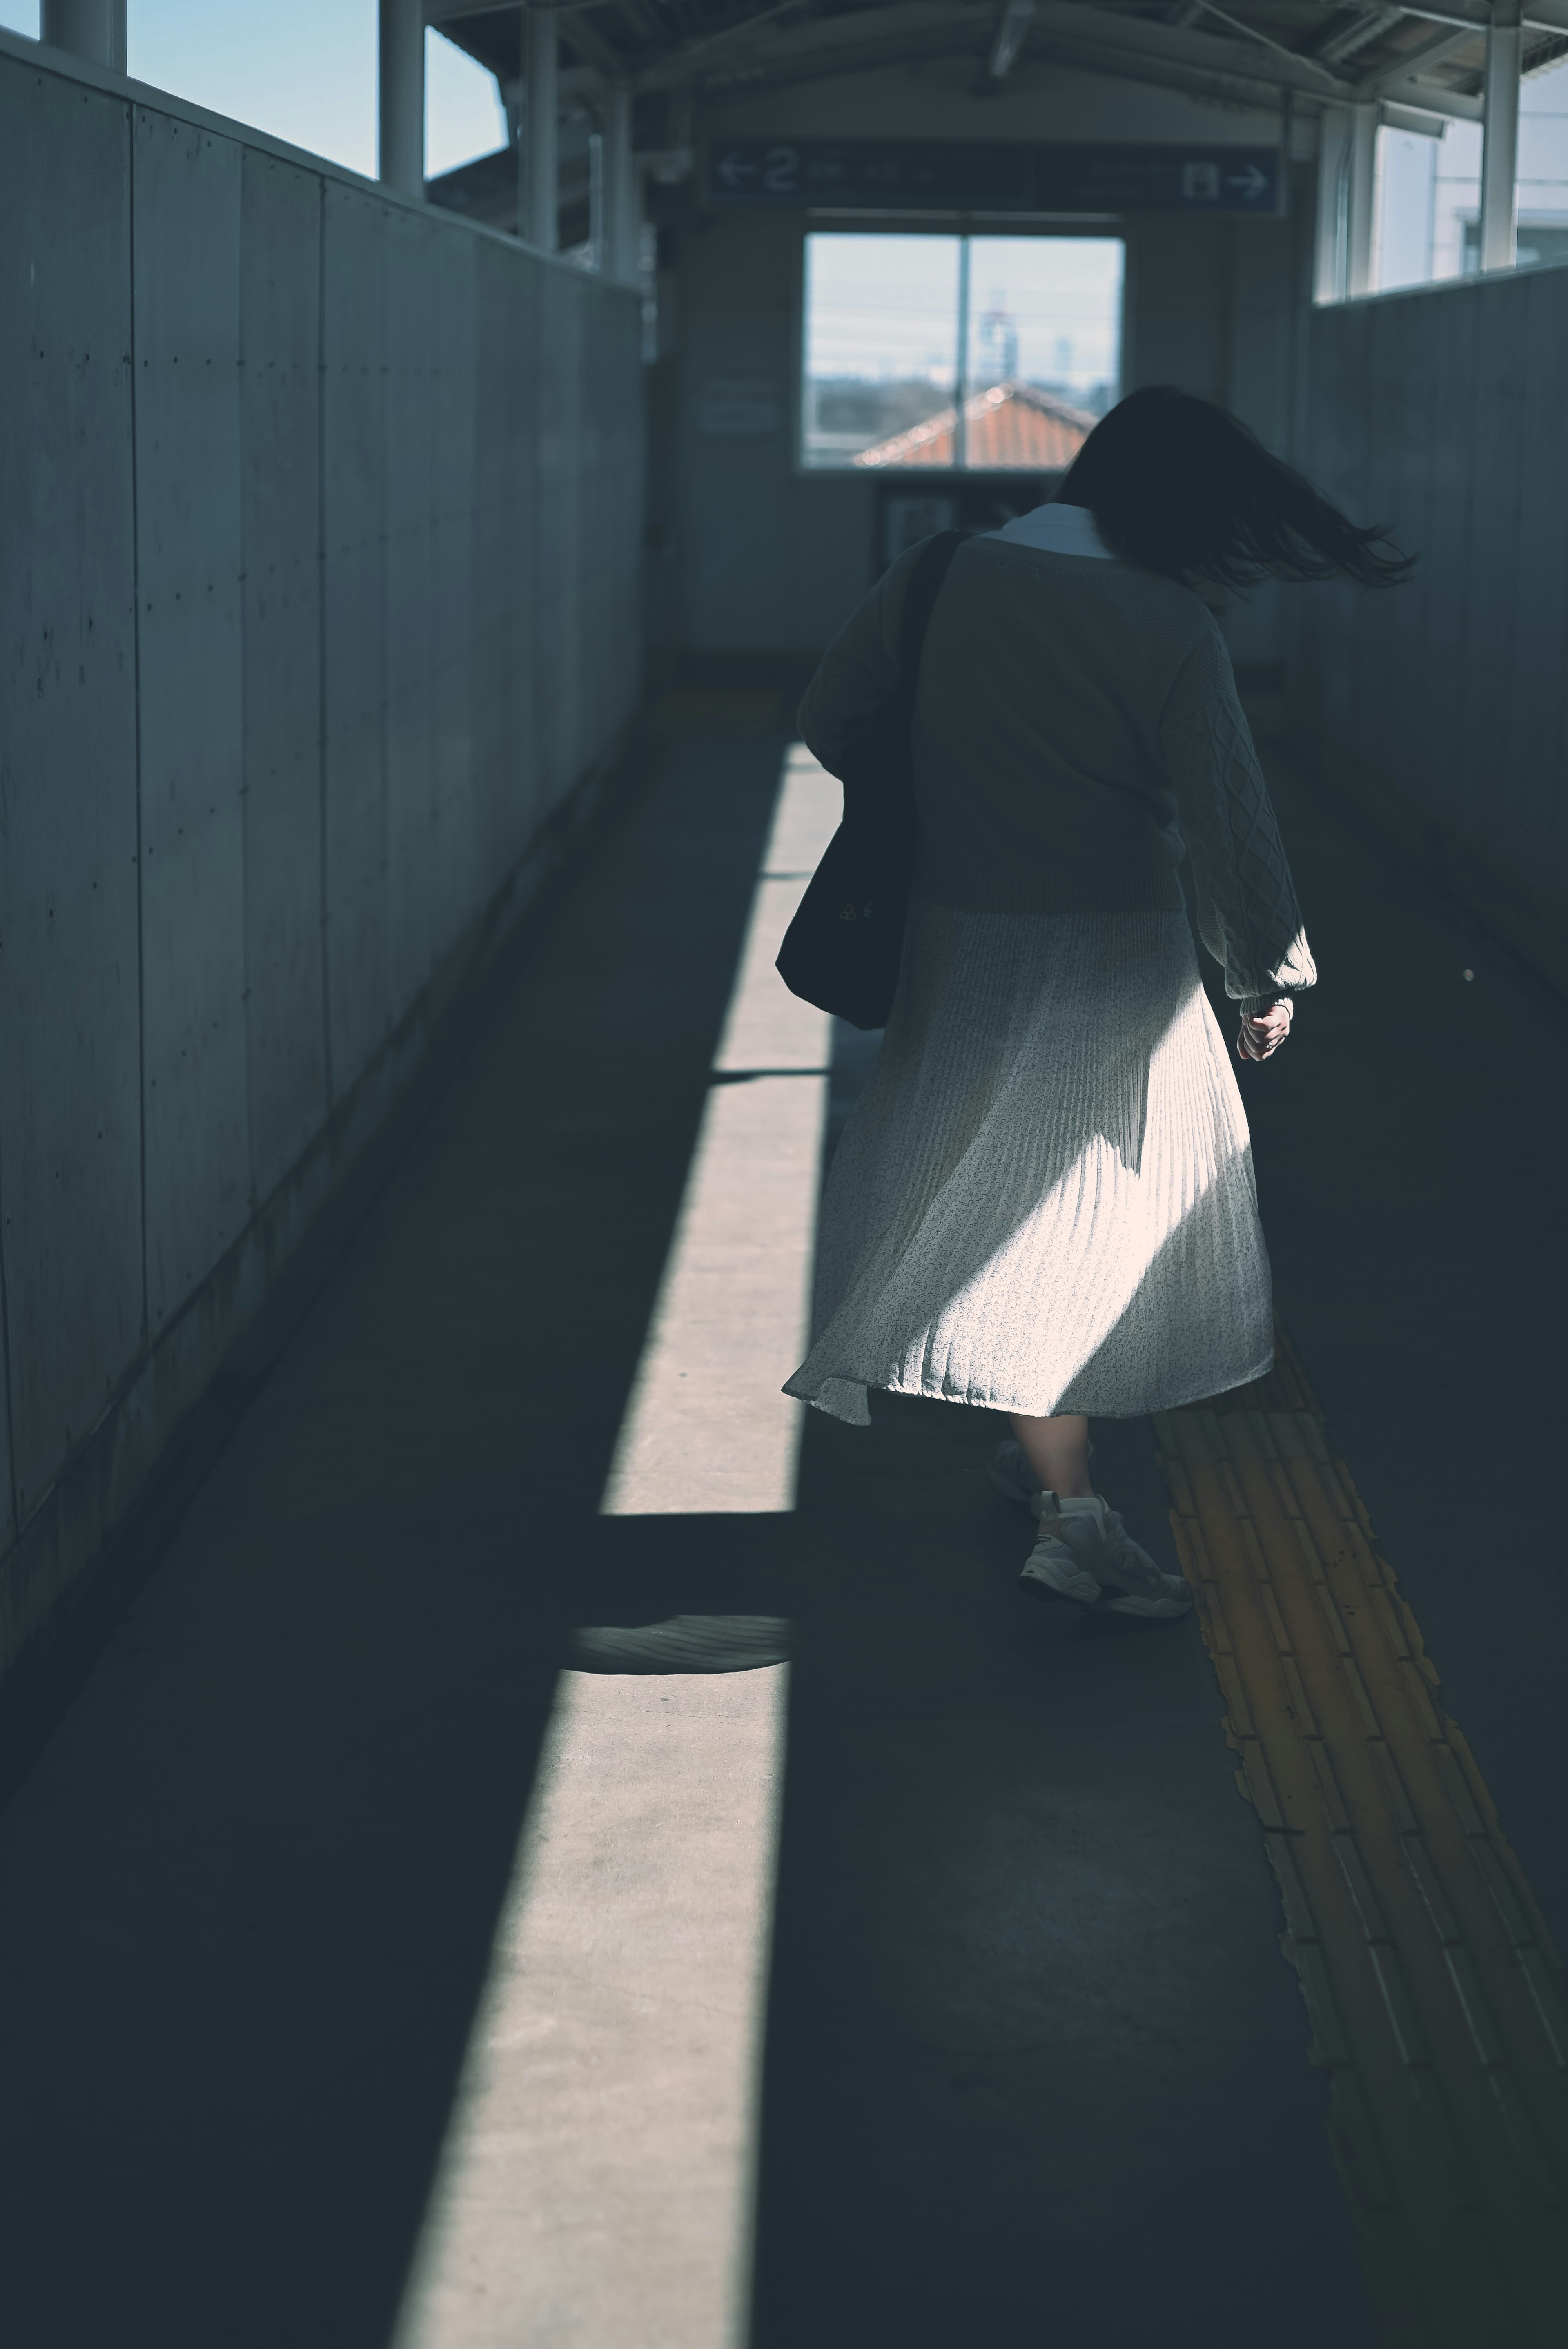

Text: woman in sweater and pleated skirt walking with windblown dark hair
xmin=786 ymin=390 xmax=1408 ymax=1618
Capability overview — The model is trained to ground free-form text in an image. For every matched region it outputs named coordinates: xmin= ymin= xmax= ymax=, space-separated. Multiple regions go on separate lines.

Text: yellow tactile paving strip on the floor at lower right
xmin=1157 ymin=1344 xmax=1568 ymax=2349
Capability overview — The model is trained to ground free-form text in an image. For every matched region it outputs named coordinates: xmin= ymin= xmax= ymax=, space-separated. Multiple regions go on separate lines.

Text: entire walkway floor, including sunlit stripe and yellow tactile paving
xmin=0 ymin=695 xmax=1568 ymax=2349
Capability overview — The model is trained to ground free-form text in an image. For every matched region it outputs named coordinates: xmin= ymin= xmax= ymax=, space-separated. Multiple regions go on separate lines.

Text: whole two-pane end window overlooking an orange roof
xmin=800 ymin=232 xmax=1122 ymax=472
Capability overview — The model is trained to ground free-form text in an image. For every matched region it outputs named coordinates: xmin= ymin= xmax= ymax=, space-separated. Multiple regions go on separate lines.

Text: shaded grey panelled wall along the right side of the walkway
xmin=1291 ymin=268 xmax=1568 ymax=989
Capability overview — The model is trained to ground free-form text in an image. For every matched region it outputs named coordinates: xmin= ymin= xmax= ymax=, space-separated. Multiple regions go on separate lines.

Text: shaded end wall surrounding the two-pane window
xmin=650 ymin=59 xmax=1312 ymax=665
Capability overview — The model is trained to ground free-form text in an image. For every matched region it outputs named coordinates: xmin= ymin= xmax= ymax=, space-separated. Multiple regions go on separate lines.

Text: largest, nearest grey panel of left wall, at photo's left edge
xmin=0 ymin=71 xmax=143 ymax=1529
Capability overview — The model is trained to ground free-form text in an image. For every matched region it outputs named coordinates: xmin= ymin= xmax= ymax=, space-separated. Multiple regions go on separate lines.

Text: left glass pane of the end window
xmin=800 ymin=235 xmax=958 ymax=465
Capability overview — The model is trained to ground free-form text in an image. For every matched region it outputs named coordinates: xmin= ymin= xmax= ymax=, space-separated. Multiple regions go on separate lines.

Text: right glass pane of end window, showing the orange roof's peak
xmin=965 ymin=237 xmax=1122 ymax=472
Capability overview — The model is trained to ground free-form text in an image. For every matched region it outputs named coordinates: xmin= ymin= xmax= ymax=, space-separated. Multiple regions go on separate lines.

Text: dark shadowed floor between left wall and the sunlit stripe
xmin=0 ymin=738 xmax=782 ymax=2349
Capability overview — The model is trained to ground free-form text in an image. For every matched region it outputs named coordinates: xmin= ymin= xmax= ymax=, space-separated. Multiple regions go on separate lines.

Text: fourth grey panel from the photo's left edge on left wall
xmin=322 ymin=183 xmax=392 ymax=1099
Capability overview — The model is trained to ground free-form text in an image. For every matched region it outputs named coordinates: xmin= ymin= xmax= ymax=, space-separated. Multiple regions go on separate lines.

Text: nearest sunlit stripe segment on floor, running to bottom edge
xmin=396 ymin=1665 xmax=786 ymax=2349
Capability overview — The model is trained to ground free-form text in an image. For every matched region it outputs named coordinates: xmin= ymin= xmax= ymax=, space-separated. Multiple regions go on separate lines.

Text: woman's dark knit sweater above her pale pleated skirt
xmin=800 ymin=505 xmax=1317 ymax=1008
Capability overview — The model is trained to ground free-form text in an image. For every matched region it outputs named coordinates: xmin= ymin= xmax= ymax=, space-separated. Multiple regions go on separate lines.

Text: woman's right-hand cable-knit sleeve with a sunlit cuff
xmin=1160 ymin=627 xmax=1317 ymax=1012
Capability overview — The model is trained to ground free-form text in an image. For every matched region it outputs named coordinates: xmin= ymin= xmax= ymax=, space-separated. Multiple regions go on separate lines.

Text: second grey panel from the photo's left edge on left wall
xmin=131 ymin=108 xmax=251 ymax=1337
